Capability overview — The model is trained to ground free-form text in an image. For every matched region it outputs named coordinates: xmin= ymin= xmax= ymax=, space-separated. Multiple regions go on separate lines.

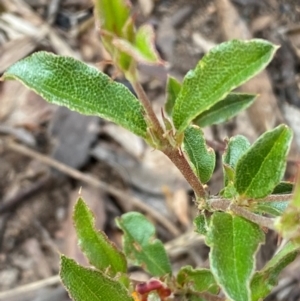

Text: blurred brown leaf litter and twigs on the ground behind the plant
xmin=0 ymin=0 xmax=300 ymax=301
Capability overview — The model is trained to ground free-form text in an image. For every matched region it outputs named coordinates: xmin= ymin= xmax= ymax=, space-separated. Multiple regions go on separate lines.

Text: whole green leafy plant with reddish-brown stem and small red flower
xmin=2 ymin=0 xmax=300 ymax=301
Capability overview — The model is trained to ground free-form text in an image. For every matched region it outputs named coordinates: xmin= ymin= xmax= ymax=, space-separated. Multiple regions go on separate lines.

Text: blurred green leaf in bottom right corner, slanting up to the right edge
xmin=251 ymin=242 xmax=300 ymax=301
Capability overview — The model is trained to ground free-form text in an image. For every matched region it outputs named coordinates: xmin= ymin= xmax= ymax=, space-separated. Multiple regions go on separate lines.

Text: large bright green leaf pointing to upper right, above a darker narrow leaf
xmin=173 ymin=39 xmax=278 ymax=132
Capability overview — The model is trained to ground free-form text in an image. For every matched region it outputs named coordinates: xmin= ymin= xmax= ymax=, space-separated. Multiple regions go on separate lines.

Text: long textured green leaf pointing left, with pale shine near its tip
xmin=4 ymin=52 xmax=147 ymax=138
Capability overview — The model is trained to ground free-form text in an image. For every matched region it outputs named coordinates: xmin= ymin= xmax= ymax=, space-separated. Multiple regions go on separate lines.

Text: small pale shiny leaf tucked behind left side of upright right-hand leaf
xmin=222 ymin=135 xmax=250 ymax=186
